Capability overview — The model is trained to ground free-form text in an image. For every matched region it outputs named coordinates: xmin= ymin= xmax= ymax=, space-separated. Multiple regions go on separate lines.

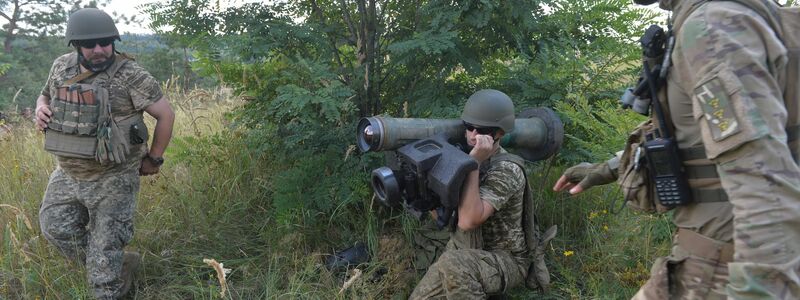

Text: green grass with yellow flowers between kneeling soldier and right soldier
xmin=520 ymin=168 xmax=672 ymax=299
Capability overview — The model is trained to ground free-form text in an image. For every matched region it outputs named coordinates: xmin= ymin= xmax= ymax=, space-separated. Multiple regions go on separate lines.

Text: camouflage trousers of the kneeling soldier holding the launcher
xmin=409 ymin=229 xmax=529 ymax=299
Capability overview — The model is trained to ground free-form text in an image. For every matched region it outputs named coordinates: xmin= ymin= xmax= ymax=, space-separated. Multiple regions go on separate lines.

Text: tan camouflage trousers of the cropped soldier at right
xmin=631 ymin=229 xmax=733 ymax=300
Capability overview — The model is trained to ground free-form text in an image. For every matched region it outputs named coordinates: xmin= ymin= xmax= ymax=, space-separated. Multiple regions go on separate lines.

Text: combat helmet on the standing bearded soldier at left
xmin=66 ymin=7 xmax=120 ymax=46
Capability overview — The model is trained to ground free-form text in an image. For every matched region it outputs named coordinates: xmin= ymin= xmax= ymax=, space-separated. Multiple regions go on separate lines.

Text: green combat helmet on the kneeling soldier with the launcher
xmin=461 ymin=89 xmax=514 ymax=133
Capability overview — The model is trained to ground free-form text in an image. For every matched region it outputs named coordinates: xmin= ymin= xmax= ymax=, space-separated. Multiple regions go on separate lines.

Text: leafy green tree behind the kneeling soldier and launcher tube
xmin=145 ymin=0 xmax=652 ymax=241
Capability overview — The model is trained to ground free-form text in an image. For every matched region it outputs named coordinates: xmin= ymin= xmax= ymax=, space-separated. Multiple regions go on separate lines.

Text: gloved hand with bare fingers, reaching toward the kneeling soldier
xmin=553 ymin=162 xmax=616 ymax=195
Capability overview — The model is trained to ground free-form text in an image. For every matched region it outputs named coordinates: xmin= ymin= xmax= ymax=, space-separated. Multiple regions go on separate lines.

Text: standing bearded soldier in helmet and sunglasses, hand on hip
xmin=35 ymin=8 xmax=175 ymax=299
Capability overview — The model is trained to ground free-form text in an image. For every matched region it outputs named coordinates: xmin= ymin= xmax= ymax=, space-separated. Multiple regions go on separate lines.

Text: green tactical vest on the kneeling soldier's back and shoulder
xmin=480 ymin=153 xmax=558 ymax=291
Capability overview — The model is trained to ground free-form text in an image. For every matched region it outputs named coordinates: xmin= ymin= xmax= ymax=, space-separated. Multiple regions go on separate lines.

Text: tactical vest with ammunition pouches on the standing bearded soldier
xmin=44 ymin=54 xmax=147 ymax=164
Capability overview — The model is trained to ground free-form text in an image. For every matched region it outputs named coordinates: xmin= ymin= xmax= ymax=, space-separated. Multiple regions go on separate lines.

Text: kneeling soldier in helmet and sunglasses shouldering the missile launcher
xmin=410 ymin=90 xmax=530 ymax=299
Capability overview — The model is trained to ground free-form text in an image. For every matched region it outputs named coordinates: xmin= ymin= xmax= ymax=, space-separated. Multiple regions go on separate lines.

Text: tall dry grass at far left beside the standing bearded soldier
xmin=0 ymin=107 xmax=92 ymax=299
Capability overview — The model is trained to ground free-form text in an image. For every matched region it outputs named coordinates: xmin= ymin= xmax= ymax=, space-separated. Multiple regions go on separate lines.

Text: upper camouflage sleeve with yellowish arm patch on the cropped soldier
xmin=673 ymin=1 xmax=787 ymax=159
